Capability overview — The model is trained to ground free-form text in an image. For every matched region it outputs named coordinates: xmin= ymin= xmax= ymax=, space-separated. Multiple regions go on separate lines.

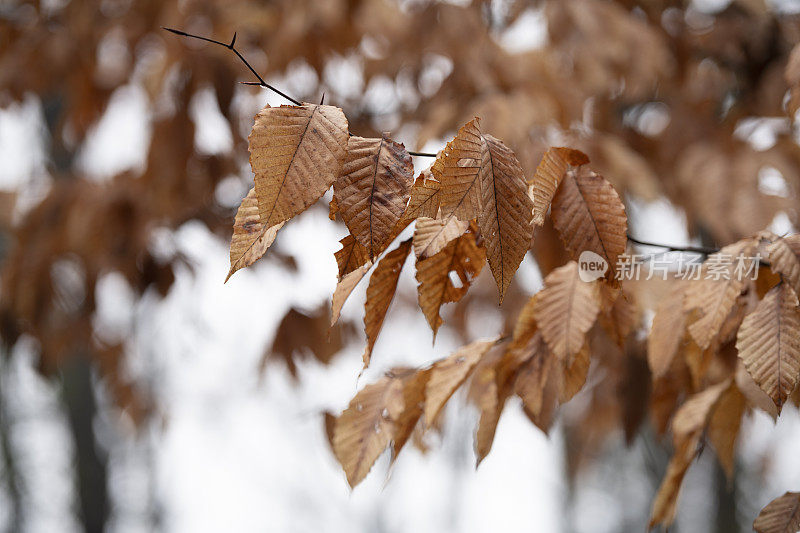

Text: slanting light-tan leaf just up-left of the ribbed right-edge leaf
xmin=684 ymin=239 xmax=755 ymax=350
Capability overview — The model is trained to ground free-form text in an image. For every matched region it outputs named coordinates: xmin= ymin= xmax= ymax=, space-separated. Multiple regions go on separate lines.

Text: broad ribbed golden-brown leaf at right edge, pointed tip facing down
xmin=736 ymin=283 xmax=800 ymax=412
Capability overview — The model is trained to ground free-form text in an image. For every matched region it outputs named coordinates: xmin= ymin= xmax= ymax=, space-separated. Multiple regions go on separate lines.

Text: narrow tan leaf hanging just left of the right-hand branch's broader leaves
xmin=647 ymin=283 xmax=686 ymax=379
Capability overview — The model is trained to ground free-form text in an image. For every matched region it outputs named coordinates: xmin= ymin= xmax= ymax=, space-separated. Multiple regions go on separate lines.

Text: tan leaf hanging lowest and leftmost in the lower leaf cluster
xmin=333 ymin=376 xmax=405 ymax=487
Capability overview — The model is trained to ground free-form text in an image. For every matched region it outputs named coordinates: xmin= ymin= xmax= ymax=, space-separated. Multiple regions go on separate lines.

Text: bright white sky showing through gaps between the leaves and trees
xmin=0 ymin=4 xmax=800 ymax=533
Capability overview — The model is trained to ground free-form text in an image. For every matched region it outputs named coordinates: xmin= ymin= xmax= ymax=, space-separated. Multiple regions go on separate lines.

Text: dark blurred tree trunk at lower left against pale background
xmin=61 ymin=358 xmax=109 ymax=533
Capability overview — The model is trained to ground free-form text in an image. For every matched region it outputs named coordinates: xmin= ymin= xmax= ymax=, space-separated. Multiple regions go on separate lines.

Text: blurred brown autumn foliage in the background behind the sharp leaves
xmin=0 ymin=0 xmax=800 ymax=532
